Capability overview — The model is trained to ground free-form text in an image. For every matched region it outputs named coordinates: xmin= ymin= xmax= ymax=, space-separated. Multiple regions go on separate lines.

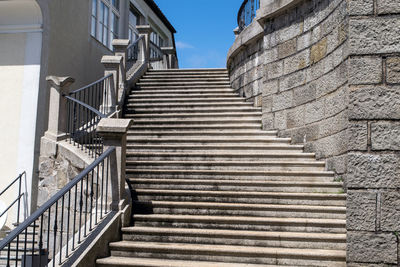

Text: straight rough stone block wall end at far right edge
xmin=347 ymin=0 xmax=400 ymax=266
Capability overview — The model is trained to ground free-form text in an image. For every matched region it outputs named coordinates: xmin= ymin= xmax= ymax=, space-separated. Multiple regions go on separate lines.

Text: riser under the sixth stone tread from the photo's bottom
xmin=138 ymin=196 xmax=346 ymax=206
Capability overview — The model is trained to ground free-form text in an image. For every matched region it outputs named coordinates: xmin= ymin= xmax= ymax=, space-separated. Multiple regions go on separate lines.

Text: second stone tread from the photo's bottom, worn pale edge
xmin=110 ymin=241 xmax=346 ymax=260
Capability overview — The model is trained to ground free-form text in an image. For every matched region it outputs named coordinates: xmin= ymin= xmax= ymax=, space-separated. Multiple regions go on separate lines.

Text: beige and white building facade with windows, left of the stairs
xmin=0 ymin=0 xmax=175 ymax=230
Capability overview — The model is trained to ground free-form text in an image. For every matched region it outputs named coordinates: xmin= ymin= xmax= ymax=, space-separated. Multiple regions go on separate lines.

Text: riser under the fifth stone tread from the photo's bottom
xmin=133 ymin=207 xmax=346 ymax=219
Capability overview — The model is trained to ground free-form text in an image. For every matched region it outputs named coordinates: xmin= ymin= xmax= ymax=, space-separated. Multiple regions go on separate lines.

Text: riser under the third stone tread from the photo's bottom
xmin=123 ymin=236 xmax=346 ymax=250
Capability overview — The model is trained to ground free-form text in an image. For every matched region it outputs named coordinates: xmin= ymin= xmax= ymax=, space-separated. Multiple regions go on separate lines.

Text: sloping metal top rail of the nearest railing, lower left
xmin=0 ymin=147 xmax=116 ymax=251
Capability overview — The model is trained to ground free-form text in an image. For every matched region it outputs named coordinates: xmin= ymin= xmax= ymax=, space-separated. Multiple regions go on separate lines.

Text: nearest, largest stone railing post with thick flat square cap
xmin=97 ymin=118 xmax=133 ymax=211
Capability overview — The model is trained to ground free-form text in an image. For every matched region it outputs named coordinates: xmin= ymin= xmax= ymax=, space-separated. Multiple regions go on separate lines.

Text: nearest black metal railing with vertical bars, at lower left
xmin=0 ymin=147 xmax=116 ymax=266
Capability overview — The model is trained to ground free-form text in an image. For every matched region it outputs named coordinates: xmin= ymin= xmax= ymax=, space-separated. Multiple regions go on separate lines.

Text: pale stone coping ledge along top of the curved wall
xmin=227 ymin=0 xmax=304 ymax=67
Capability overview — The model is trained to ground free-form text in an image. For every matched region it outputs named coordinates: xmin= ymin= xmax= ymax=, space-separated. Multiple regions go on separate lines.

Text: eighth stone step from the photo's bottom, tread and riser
xmin=126 ymin=169 xmax=334 ymax=182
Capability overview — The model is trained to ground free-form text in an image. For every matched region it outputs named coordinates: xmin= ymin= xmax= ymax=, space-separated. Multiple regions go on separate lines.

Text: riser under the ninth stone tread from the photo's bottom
xmin=127 ymin=165 xmax=325 ymax=171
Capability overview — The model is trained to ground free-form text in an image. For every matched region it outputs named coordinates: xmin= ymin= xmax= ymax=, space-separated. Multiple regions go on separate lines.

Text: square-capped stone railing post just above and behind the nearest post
xmin=101 ymin=56 xmax=122 ymax=113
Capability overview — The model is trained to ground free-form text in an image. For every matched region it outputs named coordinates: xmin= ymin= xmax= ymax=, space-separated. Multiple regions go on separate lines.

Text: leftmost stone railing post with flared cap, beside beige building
xmin=45 ymin=76 xmax=75 ymax=142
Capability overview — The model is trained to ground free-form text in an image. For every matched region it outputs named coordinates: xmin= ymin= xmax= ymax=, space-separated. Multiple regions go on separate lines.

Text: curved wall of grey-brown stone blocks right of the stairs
xmin=228 ymin=0 xmax=348 ymax=176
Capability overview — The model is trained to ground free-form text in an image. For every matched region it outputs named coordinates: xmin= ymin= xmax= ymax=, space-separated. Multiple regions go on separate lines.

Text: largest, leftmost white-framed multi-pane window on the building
xmin=90 ymin=0 xmax=119 ymax=50
